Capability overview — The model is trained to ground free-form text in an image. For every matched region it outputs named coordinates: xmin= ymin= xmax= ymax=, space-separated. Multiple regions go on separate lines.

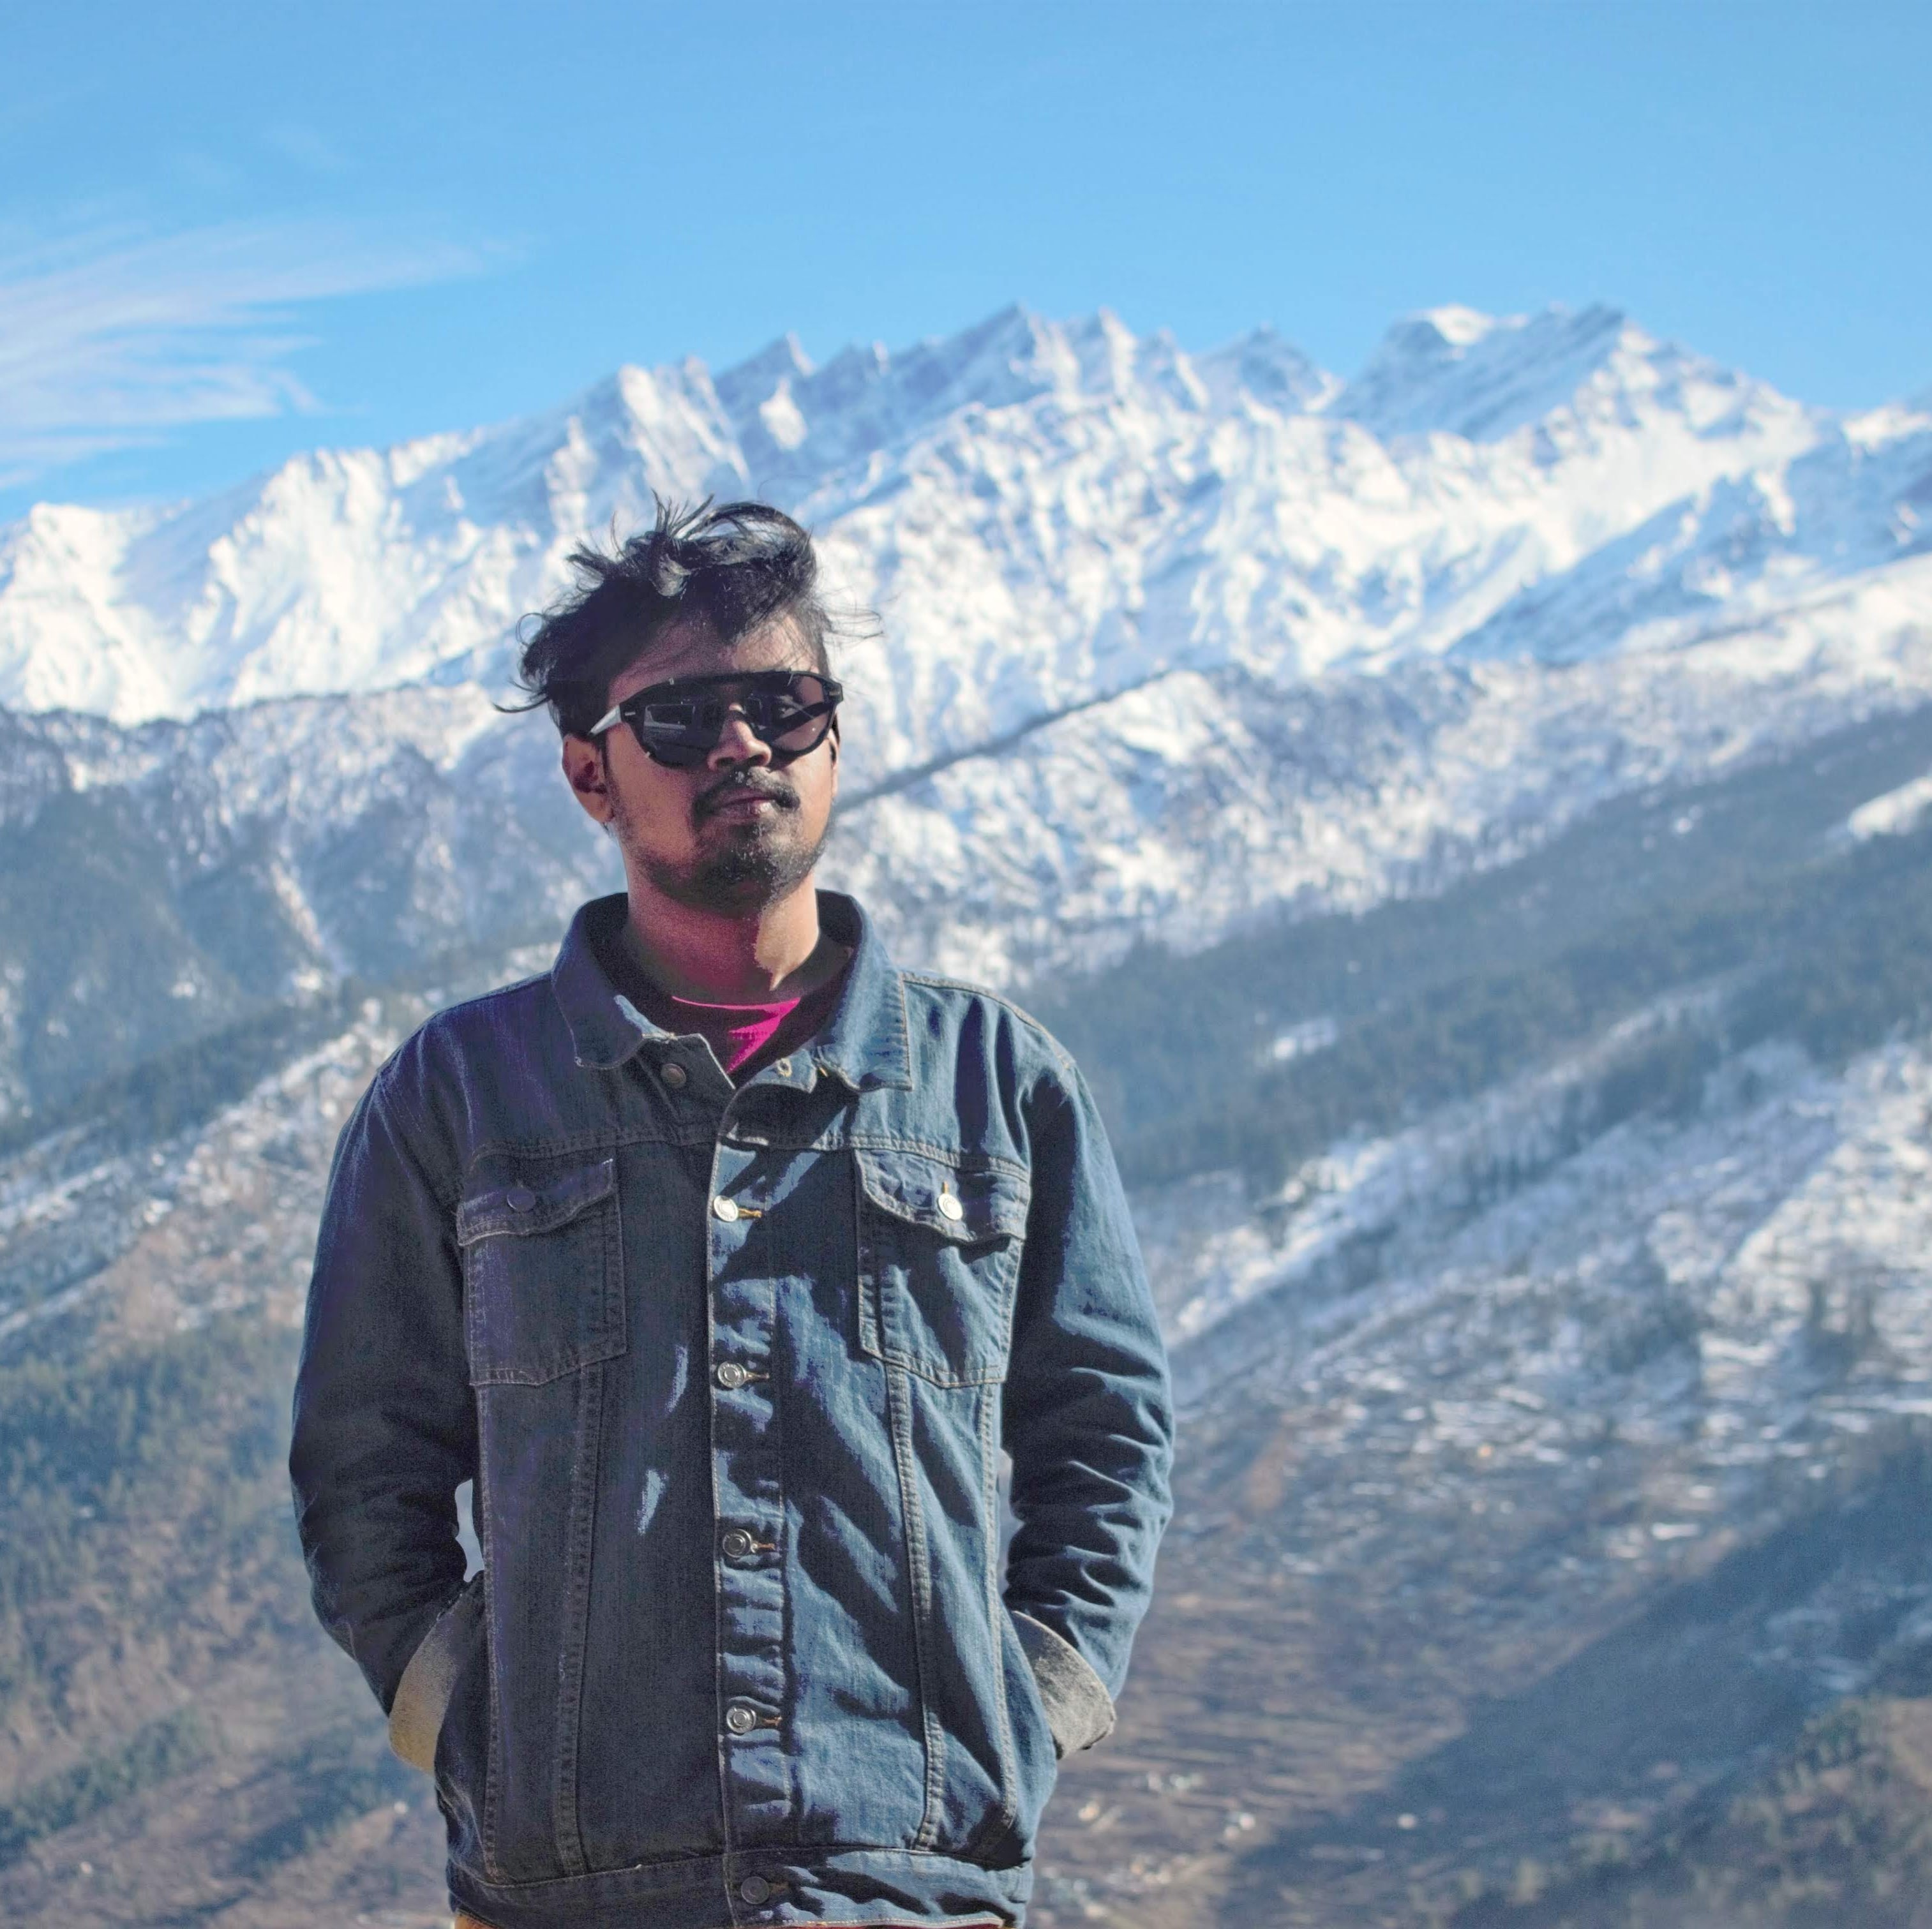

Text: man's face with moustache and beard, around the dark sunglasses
xmin=564 ymin=616 xmax=839 ymax=917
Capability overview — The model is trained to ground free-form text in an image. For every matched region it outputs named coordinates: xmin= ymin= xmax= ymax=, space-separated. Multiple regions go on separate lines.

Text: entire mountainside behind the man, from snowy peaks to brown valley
xmin=11 ymin=309 xmax=1932 ymax=1929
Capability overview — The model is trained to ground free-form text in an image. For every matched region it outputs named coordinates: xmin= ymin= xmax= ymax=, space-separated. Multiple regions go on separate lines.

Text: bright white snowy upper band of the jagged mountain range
xmin=0 ymin=307 xmax=1932 ymax=741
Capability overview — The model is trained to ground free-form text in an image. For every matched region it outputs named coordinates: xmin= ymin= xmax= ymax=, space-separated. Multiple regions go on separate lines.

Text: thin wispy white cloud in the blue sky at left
xmin=0 ymin=222 xmax=489 ymax=489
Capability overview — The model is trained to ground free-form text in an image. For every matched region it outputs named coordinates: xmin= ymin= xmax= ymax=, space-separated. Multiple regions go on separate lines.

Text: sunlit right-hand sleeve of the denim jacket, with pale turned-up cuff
xmin=1005 ymin=1068 xmax=1172 ymax=1754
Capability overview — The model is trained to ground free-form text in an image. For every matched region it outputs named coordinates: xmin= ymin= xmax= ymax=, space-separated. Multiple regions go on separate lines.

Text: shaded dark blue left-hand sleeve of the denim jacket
xmin=290 ymin=1046 xmax=476 ymax=1713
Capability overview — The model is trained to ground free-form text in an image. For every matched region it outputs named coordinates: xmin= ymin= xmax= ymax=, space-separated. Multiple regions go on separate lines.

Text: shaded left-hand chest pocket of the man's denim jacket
xmin=456 ymin=1159 xmax=624 ymax=1387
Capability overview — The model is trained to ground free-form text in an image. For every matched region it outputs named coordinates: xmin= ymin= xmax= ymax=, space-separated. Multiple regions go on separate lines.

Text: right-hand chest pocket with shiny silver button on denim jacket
xmin=854 ymin=1151 xmax=1030 ymax=1387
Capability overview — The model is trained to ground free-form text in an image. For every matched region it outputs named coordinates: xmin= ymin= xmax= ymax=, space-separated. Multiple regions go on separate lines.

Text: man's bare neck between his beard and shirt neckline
xmin=624 ymin=879 xmax=846 ymax=1004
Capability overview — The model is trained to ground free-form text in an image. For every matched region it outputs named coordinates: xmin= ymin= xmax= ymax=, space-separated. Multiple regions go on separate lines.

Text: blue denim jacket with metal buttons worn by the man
xmin=290 ymin=894 xmax=1171 ymax=1929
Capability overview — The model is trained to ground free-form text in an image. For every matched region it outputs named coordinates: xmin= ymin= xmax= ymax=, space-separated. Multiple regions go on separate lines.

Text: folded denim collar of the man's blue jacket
xmin=551 ymin=890 xmax=912 ymax=1091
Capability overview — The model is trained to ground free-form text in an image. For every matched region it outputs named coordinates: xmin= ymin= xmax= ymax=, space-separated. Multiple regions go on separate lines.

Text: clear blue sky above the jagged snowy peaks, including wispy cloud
xmin=0 ymin=0 xmax=1932 ymax=516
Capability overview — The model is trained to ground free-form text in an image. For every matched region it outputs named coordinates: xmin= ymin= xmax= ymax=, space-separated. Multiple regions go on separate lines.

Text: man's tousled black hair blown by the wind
xmin=516 ymin=496 xmax=837 ymax=736
